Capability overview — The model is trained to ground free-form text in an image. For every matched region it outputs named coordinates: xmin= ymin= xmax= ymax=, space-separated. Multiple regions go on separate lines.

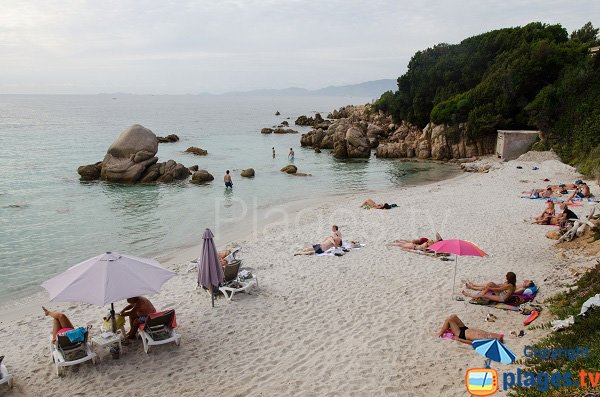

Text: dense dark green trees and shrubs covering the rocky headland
xmin=375 ymin=22 xmax=600 ymax=175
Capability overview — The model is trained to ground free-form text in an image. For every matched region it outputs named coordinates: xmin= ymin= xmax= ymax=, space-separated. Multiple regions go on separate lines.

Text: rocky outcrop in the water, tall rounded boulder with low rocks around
xmin=77 ymin=124 xmax=190 ymax=183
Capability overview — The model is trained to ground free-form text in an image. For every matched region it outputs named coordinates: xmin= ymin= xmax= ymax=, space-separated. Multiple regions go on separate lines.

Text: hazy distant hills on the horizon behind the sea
xmin=223 ymin=79 xmax=398 ymax=98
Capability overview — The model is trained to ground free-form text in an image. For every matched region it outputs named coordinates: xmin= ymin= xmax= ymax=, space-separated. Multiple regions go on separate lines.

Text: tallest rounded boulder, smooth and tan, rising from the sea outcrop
xmin=100 ymin=124 xmax=158 ymax=183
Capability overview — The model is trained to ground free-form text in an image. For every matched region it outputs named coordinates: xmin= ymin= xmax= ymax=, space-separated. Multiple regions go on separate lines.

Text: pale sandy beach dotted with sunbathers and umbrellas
xmin=0 ymin=153 xmax=600 ymax=396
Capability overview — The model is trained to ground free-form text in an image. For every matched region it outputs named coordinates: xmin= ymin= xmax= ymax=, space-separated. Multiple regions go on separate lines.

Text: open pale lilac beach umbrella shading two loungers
xmin=42 ymin=252 xmax=175 ymax=332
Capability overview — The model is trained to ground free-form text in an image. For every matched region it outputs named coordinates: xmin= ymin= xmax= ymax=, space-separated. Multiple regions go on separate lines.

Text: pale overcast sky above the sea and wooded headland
xmin=0 ymin=0 xmax=600 ymax=94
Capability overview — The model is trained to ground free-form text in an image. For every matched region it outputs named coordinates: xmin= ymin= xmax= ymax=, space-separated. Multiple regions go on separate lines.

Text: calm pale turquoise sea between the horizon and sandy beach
xmin=0 ymin=95 xmax=457 ymax=297
